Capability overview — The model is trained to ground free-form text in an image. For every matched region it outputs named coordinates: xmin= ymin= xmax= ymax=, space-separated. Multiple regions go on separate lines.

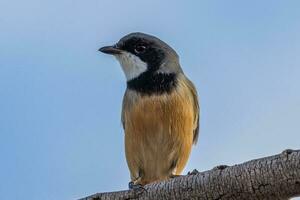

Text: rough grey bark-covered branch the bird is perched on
xmin=81 ymin=150 xmax=300 ymax=200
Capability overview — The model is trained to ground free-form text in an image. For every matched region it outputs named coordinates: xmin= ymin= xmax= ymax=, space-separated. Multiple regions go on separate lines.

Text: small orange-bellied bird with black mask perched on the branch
xmin=99 ymin=32 xmax=200 ymax=189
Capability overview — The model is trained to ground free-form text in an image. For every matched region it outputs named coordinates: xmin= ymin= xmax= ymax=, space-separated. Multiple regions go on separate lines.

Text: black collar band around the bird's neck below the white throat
xmin=127 ymin=71 xmax=177 ymax=95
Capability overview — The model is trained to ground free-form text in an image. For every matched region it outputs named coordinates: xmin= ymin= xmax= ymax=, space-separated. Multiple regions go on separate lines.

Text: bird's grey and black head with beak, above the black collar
xmin=99 ymin=33 xmax=182 ymax=81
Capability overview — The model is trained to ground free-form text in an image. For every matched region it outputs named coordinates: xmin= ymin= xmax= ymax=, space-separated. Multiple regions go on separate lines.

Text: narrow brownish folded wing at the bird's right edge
xmin=186 ymin=78 xmax=200 ymax=144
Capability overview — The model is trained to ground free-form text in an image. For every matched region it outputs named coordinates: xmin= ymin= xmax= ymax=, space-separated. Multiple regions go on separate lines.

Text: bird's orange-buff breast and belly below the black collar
xmin=123 ymin=79 xmax=195 ymax=185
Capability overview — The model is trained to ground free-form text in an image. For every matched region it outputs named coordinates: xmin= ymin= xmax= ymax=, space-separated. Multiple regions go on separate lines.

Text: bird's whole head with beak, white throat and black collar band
xmin=99 ymin=33 xmax=182 ymax=95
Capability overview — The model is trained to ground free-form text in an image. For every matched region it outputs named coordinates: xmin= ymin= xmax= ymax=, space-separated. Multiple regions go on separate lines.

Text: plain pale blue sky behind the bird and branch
xmin=0 ymin=0 xmax=300 ymax=200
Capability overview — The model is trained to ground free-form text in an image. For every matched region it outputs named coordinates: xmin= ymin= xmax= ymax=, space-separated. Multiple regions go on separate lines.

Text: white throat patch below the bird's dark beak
xmin=115 ymin=52 xmax=147 ymax=81
